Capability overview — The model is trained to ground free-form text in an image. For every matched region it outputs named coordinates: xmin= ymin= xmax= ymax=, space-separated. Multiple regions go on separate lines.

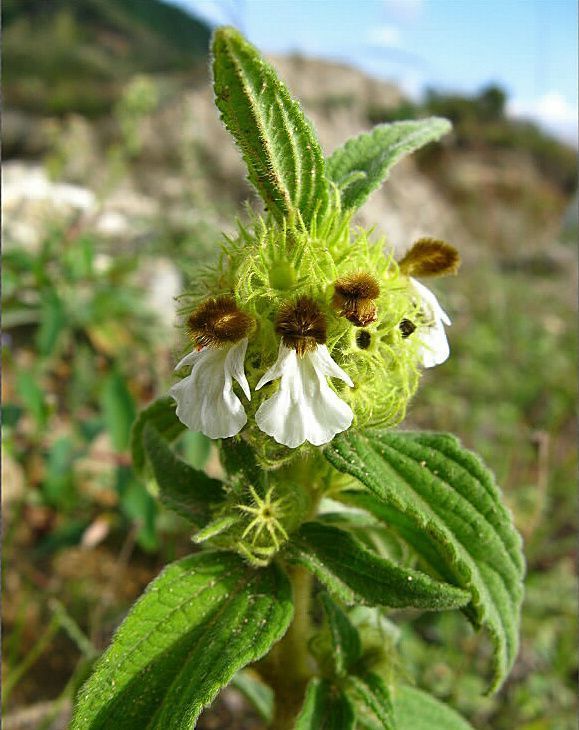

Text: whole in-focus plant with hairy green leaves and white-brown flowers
xmin=72 ymin=28 xmax=524 ymax=730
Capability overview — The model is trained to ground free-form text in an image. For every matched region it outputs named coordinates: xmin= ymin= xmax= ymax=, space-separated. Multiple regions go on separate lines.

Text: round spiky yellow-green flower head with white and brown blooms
xmin=170 ymin=219 xmax=458 ymax=449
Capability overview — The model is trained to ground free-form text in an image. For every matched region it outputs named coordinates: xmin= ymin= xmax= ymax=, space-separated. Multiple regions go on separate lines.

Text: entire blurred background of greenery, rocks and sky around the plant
xmin=2 ymin=0 xmax=578 ymax=730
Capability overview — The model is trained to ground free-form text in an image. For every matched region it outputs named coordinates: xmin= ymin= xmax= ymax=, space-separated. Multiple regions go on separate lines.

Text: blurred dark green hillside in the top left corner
xmin=2 ymin=0 xmax=210 ymax=117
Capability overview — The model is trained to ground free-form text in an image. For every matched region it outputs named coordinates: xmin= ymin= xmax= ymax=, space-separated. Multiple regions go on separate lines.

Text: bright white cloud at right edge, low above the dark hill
xmin=507 ymin=91 xmax=577 ymax=145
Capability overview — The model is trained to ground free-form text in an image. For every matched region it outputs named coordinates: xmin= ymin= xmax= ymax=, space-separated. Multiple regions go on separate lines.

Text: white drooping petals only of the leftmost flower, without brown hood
xmin=169 ymin=337 xmax=251 ymax=439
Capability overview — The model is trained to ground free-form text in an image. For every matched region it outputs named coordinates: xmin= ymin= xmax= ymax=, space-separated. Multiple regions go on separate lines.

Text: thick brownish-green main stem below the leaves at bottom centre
xmin=260 ymin=566 xmax=312 ymax=730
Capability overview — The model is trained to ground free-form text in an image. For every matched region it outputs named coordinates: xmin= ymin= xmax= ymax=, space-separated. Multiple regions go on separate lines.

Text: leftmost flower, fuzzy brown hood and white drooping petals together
xmin=169 ymin=296 xmax=254 ymax=439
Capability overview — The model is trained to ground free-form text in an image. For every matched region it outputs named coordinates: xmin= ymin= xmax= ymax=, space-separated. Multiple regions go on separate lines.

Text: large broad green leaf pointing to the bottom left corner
xmin=71 ymin=552 xmax=293 ymax=730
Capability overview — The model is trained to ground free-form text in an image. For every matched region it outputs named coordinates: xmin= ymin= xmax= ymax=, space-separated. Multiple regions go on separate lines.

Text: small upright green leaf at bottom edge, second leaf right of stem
xmin=345 ymin=672 xmax=399 ymax=730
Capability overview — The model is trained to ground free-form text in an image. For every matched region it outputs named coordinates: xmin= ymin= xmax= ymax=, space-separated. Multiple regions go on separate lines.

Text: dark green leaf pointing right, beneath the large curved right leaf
xmin=288 ymin=522 xmax=470 ymax=611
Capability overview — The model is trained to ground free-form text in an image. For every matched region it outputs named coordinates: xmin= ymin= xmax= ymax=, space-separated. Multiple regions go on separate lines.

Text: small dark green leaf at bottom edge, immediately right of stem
xmin=294 ymin=678 xmax=356 ymax=730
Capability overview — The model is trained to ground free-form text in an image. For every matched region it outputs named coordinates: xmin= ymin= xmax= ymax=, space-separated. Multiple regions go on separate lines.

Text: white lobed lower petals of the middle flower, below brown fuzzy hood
xmin=255 ymin=342 xmax=354 ymax=449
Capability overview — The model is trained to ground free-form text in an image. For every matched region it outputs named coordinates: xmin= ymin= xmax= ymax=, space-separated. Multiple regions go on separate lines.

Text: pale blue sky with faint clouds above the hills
xmin=169 ymin=0 xmax=578 ymax=144
